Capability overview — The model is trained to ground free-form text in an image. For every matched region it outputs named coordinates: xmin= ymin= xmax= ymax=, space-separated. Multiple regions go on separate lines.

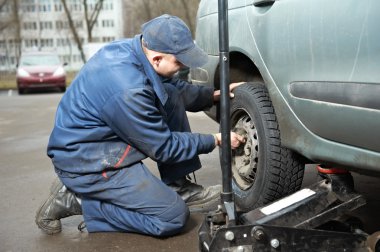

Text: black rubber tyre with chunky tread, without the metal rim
xmin=230 ymin=83 xmax=304 ymax=211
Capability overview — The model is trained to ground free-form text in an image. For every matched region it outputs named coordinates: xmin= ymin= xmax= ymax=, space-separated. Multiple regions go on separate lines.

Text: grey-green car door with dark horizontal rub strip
xmin=246 ymin=0 xmax=380 ymax=151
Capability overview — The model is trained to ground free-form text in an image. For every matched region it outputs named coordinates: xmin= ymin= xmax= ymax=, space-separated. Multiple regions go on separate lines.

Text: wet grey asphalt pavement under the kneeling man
xmin=0 ymin=91 xmax=380 ymax=252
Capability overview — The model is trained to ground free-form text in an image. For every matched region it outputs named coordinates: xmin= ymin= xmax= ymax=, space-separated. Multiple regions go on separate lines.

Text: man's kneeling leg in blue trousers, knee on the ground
xmin=62 ymin=163 xmax=189 ymax=236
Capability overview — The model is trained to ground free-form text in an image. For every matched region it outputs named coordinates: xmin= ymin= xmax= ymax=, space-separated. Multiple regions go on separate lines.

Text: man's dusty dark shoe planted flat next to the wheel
xmin=168 ymin=178 xmax=222 ymax=213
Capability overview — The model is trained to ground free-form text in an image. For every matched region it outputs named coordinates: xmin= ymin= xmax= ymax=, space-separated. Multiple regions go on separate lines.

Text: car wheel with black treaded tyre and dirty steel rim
xmin=227 ymin=82 xmax=305 ymax=211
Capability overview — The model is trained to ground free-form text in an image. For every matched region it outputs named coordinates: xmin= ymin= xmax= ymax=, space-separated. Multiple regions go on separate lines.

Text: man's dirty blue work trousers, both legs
xmin=56 ymin=81 xmax=201 ymax=236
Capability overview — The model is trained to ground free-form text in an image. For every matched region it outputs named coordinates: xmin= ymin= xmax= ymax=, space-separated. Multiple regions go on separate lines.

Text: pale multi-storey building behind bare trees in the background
xmin=0 ymin=0 xmax=123 ymax=71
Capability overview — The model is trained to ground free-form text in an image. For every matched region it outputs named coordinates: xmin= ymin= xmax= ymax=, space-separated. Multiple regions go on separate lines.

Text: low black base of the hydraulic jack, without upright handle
xmin=199 ymin=170 xmax=380 ymax=252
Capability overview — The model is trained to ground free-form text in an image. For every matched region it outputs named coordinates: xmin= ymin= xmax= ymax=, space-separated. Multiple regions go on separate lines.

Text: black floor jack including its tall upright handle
xmin=198 ymin=0 xmax=380 ymax=252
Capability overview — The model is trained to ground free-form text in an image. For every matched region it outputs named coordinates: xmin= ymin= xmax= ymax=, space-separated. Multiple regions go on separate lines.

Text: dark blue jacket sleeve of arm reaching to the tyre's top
xmin=171 ymin=78 xmax=214 ymax=112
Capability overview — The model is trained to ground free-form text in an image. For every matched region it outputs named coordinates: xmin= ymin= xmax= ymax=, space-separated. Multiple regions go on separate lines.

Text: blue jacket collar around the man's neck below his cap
xmin=132 ymin=34 xmax=168 ymax=106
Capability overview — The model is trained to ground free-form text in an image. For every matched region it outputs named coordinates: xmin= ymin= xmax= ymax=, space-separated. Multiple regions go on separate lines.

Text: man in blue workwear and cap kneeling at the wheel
xmin=36 ymin=15 xmax=244 ymax=236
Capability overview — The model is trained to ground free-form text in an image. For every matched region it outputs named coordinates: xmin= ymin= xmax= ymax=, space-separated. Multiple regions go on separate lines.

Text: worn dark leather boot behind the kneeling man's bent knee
xmin=36 ymin=179 xmax=82 ymax=235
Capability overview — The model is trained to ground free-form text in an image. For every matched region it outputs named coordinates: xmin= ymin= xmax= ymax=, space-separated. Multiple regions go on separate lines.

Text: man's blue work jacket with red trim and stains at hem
xmin=47 ymin=35 xmax=215 ymax=174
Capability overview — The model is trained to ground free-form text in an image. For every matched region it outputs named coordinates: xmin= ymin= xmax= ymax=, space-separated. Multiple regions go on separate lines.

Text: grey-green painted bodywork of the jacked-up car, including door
xmin=191 ymin=0 xmax=380 ymax=173
